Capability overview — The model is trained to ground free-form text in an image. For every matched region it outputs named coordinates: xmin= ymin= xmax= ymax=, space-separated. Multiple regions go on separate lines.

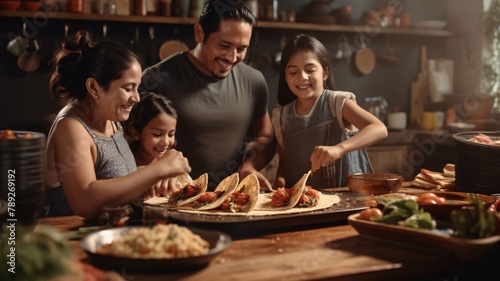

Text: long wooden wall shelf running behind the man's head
xmin=0 ymin=11 xmax=452 ymax=37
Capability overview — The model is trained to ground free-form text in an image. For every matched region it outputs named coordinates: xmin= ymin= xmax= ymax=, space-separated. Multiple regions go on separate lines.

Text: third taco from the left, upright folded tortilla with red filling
xmin=220 ymin=174 xmax=260 ymax=213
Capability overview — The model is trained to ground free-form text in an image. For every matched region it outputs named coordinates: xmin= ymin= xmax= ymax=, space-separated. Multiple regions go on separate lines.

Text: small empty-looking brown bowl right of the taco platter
xmin=347 ymin=173 xmax=403 ymax=195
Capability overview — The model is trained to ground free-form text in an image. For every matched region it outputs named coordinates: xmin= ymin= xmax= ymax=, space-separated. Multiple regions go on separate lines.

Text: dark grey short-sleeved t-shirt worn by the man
xmin=140 ymin=52 xmax=269 ymax=189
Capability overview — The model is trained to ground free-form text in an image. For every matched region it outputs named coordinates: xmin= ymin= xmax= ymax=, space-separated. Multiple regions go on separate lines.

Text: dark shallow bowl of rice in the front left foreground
xmin=80 ymin=224 xmax=231 ymax=271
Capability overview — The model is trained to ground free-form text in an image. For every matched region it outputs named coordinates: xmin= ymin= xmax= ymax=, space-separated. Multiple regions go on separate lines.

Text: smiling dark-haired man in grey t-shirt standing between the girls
xmin=141 ymin=0 xmax=275 ymax=190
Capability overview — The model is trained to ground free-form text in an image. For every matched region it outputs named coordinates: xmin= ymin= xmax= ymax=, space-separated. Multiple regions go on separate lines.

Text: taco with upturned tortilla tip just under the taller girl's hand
xmin=255 ymin=168 xmax=311 ymax=210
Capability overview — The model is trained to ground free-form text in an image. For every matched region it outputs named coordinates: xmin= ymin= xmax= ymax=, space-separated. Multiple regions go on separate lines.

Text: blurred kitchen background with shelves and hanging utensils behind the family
xmin=0 ymin=0 xmax=500 ymax=180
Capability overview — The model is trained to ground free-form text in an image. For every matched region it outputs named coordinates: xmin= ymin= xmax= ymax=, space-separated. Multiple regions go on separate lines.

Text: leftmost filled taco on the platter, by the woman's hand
xmin=144 ymin=173 xmax=208 ymax=206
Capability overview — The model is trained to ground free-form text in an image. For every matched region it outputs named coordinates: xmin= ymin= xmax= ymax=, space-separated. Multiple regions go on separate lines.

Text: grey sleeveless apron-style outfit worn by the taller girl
xmin=274 ymin=90 xmax=373 ymax=189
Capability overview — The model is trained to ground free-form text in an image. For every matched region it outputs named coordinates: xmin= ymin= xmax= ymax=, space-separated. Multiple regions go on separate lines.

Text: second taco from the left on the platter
xmin=192 ymin=173 xmax=240 ymax=210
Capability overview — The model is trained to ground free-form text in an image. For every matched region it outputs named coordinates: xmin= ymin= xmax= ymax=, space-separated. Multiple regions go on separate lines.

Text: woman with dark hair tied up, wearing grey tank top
xmin=47 ymin=30 xmax=191 ymax=219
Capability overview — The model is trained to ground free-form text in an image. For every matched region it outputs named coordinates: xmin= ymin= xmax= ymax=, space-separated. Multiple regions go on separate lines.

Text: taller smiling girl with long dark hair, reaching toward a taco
xmin=272 ymin=34 xmax=387 ymax=189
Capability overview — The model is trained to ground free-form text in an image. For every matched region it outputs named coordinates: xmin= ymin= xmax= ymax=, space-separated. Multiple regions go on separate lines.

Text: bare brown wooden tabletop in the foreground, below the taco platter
xmin=38 ymin=213 xmax=500 ymax=281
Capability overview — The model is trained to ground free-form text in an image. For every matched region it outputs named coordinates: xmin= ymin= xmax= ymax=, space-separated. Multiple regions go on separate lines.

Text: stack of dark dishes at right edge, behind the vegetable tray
xmin=453 ymin=132 xmax=500 ymax=195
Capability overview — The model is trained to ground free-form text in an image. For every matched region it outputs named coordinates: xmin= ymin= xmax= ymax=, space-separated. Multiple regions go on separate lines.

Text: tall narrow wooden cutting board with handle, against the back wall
xmin=410 ymin=46 xmax=429 ymax=128
